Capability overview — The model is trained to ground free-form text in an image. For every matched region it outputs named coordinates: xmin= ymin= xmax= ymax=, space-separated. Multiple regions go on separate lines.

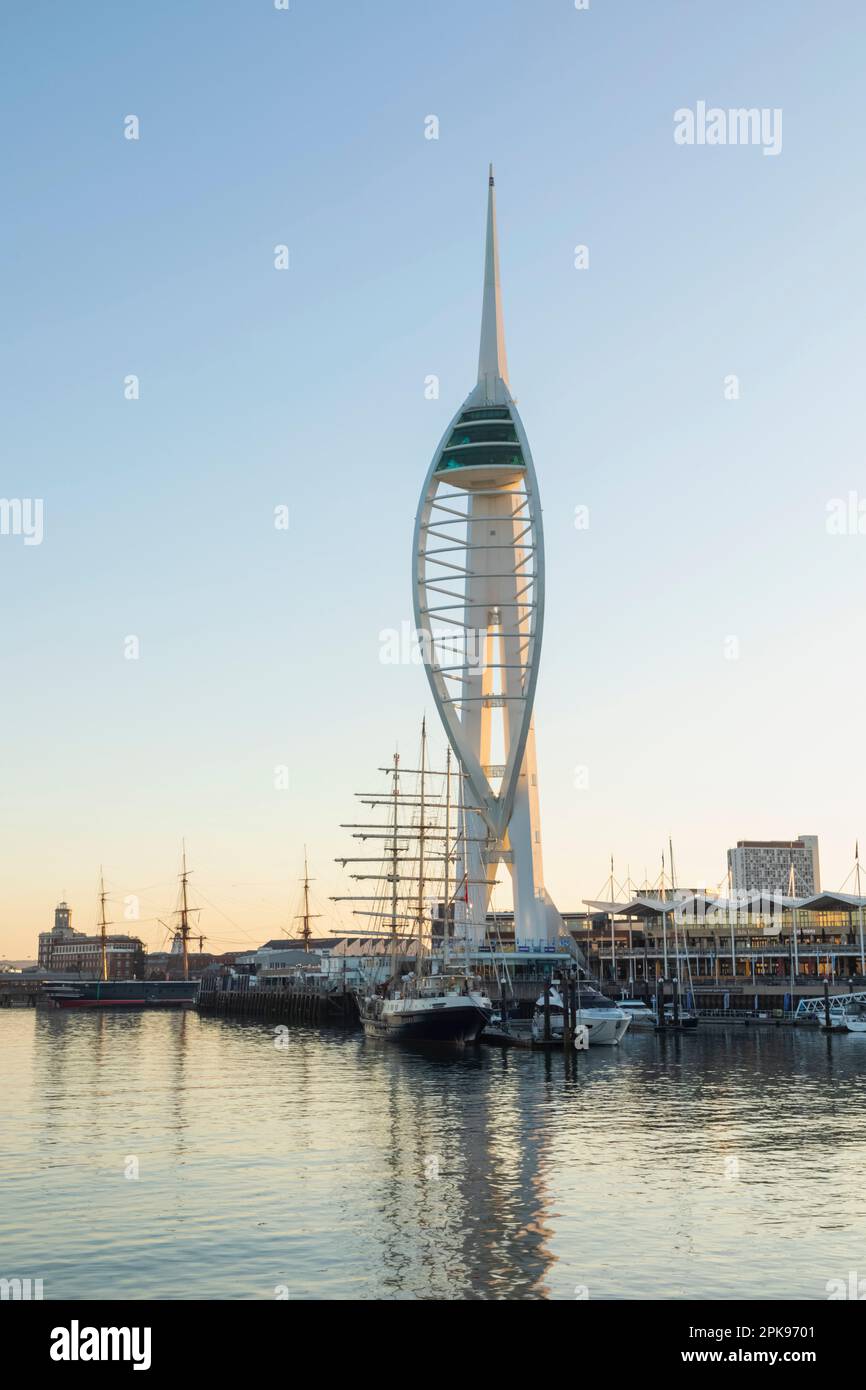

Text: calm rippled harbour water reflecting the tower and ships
xmin=0 ymin=1009 xmax=866 ymax=1300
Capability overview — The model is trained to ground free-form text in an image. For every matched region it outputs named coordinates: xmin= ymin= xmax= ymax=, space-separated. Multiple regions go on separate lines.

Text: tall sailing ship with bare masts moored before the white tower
xmin=335 ymin=723 xmax=493 ymax=1044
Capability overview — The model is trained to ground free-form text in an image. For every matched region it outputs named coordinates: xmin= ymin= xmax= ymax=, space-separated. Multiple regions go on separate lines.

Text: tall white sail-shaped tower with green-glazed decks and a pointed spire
xmin=413 ymin=165 xmax=562 ymax=945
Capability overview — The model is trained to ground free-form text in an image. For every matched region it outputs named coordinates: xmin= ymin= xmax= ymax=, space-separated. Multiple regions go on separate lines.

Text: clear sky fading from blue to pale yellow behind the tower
xmin=0 ymin=0 xmax=866 ymax=955
